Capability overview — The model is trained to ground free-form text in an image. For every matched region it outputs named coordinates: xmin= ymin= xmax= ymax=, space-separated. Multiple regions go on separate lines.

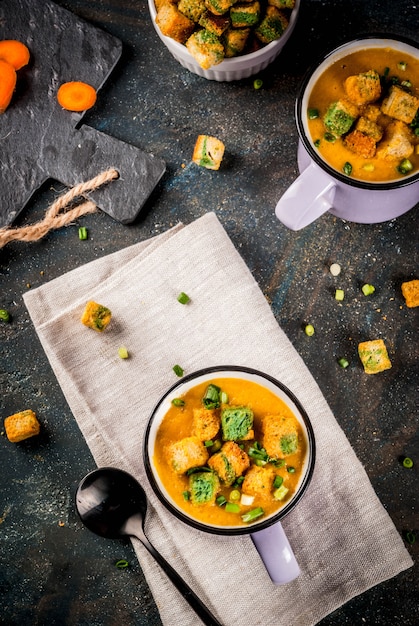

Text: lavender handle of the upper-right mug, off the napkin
xmin=275 ymin=162 xmax=336 ymax=230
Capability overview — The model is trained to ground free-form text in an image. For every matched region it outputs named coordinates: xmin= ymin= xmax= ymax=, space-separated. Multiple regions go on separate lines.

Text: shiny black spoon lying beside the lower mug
xmin=76 ymin=467 xmax=222 ymax=626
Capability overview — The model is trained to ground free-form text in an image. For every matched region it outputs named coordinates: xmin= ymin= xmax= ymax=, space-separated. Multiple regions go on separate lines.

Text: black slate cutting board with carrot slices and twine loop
xmin=0 ymin=0 xmax=165 ymax=227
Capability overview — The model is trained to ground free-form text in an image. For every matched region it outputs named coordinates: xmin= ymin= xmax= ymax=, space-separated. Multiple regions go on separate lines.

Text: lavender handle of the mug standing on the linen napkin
xmin=250 ymin=522 xmax=300 ymax=585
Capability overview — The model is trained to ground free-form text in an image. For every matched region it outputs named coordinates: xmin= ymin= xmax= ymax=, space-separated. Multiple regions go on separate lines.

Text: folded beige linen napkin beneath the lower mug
xmin=24 ymin=213 xmax=412 ymax=626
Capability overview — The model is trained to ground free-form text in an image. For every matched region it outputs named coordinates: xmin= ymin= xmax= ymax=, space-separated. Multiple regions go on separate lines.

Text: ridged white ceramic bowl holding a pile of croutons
xmin=148 ymin=0 xmax=300 ymax=82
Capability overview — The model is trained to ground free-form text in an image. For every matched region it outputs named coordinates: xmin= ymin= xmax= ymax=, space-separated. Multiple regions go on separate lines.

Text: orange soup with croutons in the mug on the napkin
xmin=153 ymin=378 xmax=307 ymax=526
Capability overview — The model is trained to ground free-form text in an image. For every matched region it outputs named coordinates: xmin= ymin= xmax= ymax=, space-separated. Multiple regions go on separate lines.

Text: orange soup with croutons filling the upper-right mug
xmin=307 ymin=48 xmax=419 ymax=182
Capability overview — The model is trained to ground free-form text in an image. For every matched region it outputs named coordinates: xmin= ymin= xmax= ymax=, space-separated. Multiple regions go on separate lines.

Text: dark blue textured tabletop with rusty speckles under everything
xmin=0 ymin=0 xmax=419 ymax=626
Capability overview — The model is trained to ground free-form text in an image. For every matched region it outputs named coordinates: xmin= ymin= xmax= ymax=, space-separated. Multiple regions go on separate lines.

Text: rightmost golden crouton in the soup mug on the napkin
xmin=262 ymin=415 xmax=300 ymax=459
